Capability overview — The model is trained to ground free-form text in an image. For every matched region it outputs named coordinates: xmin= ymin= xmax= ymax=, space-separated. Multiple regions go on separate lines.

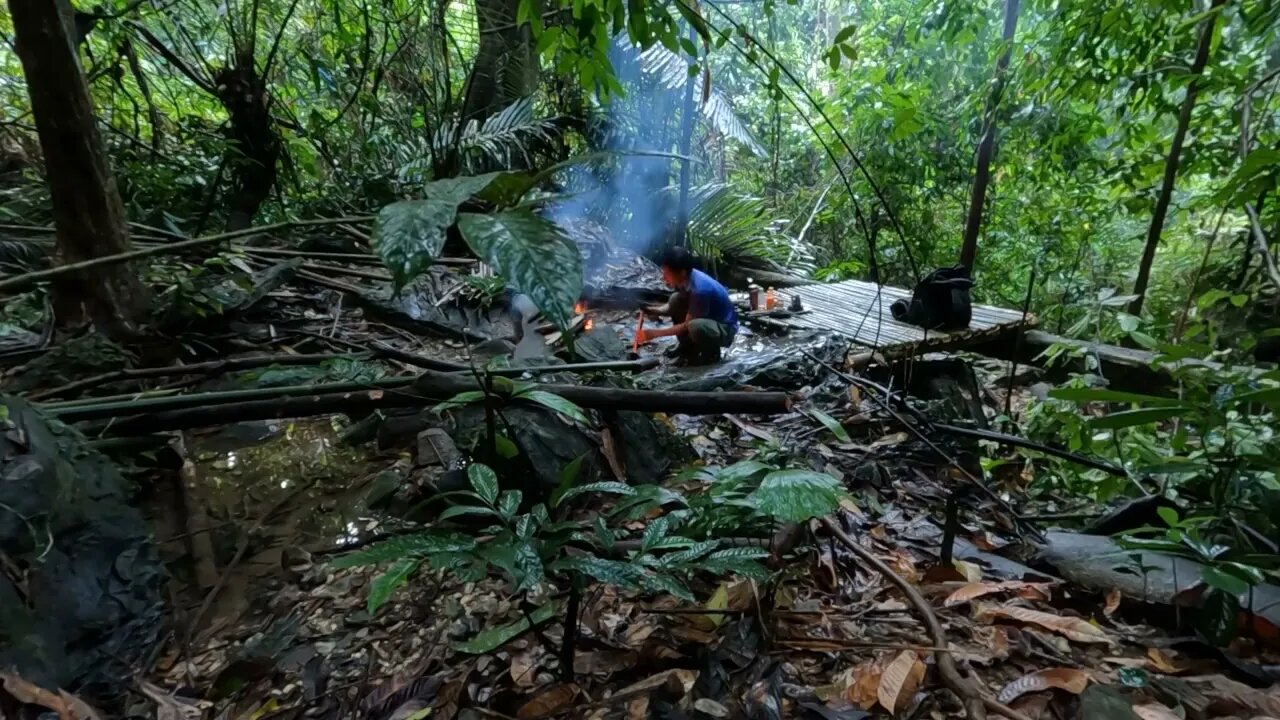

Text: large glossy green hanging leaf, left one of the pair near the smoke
xmin=374 ymin=173 xmax=500 ymax=286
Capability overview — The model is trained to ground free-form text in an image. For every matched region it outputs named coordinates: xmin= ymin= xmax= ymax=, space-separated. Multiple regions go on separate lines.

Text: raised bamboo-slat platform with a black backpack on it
xmin=748 ymin=281 xmax=1036 ymax=355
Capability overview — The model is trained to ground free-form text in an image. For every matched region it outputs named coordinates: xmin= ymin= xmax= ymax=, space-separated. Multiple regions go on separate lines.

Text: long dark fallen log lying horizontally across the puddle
xmin=44 ymin=372 xmax=791 ymax=436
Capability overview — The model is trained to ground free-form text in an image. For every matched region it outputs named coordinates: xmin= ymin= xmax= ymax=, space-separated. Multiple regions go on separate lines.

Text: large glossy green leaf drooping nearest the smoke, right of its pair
xmin=458 ymin=210 xmax=582 ymax=328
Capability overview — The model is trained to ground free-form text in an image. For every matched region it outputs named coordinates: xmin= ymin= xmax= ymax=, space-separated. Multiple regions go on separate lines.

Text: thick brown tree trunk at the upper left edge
xmin=9 ymin=0 xmax=147 ymax=337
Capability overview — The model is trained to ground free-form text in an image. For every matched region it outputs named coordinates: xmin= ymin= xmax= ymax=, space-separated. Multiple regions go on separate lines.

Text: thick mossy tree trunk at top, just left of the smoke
xmin=462 ymin=0 xmax=541 ymax=123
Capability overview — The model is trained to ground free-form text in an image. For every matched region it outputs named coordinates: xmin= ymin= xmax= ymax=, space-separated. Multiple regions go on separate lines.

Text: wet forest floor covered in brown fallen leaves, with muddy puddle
xmin=4 ymin=221 xmax=1280 ymax=720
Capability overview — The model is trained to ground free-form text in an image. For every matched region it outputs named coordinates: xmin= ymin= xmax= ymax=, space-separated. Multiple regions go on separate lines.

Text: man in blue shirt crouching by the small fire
xmin=636 ymin=247 xmax=737 ymax=365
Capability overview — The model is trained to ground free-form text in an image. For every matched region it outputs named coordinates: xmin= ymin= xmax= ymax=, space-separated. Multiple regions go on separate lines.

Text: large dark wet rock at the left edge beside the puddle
xmin=0 ymin=397 xmax=165 ymax=701
